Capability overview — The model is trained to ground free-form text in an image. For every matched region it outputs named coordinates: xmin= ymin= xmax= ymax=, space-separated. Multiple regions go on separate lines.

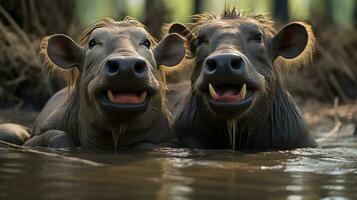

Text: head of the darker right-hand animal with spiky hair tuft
xmin=169 ymin=8 xmax=314 ymax=119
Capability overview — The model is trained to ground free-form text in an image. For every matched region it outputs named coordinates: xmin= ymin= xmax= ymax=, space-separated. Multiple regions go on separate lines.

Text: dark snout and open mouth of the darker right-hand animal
xmin=199 ymin=52 xmax=264 ymax=117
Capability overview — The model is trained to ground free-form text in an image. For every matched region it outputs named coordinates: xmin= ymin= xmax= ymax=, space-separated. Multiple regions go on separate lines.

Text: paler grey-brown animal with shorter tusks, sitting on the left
xmin=0 ymin=17 xmax=185 ymax=150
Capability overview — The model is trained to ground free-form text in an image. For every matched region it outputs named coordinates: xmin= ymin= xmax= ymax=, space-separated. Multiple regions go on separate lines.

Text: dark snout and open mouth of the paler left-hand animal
xmin=96 ymin=56 xmax=158 ymax=116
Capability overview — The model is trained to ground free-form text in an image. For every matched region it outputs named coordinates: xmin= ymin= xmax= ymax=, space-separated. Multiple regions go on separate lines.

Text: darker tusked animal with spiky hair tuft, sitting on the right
xmin=168 ymin=8 xmax=316 ymax=150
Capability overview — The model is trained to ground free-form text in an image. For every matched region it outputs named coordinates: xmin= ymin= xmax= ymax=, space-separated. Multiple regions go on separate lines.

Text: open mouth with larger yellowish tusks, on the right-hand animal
xmin=208 ymin=83 xmax=254 ymax=103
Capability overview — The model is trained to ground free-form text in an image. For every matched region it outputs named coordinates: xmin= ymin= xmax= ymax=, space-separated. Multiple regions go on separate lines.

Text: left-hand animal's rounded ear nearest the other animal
xmin=154 ymin=33 xmax=186 ymax=67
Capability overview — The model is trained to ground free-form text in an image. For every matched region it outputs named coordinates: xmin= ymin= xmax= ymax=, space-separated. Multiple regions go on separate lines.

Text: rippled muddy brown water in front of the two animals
xmin=0 ymin=111 xmax=357 ymax=200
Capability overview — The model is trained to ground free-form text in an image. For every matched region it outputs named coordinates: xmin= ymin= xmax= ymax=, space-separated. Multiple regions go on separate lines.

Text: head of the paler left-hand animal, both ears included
xmin=41 ymin=17 xmax=185 ymax=125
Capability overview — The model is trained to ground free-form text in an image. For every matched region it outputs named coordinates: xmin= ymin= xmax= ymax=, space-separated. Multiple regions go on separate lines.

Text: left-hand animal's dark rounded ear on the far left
xmin=47 ymin=34 xmax=83 ymax=69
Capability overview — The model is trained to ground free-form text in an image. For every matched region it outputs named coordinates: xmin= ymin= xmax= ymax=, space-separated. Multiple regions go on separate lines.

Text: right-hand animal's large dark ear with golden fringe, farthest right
xmin=272 ymin=22 xmax=314 ymax=59
